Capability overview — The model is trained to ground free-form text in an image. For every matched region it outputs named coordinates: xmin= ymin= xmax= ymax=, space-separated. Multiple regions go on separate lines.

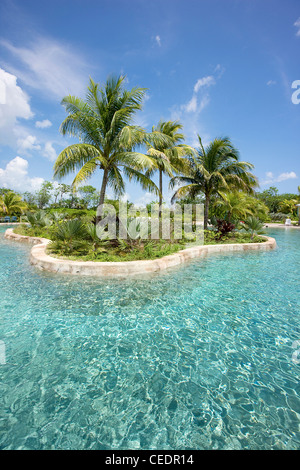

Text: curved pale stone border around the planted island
xmin=5 ymin=229 xmax=276 ymax=277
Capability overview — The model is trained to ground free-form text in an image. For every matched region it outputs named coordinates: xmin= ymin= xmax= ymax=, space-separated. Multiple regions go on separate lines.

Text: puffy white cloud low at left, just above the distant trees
xmin=0 ymin=156 xmax=44 ymax=192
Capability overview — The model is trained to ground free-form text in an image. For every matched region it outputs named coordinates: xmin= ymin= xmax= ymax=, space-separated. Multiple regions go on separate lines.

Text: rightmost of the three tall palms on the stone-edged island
xmin=171 ymin=135 xmax=257 ymax=230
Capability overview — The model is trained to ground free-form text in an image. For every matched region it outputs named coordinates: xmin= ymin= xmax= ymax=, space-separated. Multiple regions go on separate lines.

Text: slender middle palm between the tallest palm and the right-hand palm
xmin=146 ymin=121 xmax=193 ymax=217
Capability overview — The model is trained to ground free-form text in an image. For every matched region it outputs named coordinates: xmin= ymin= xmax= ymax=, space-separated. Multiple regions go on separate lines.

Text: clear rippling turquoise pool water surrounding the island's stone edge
xmin=0 ymin=227 xmax=300 ymax=450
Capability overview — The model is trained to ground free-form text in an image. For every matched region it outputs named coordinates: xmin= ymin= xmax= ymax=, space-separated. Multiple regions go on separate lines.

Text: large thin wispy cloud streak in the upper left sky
xmin=0 ymin=37 xmax=91 ymax=99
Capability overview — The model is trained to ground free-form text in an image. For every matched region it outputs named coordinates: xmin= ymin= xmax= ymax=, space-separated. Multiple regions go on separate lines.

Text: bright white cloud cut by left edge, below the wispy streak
xmin=0 ymin=68 xmax=33 ymax=145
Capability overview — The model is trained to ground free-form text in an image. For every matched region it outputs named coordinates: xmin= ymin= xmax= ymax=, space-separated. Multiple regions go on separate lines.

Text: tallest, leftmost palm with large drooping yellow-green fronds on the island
xmin=54 ymin=76 xmax=164 ymax=222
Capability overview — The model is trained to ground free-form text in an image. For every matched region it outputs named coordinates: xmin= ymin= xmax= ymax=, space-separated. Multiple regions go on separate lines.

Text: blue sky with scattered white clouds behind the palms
xmin=0 ymin=0 xmax=300 ymax=202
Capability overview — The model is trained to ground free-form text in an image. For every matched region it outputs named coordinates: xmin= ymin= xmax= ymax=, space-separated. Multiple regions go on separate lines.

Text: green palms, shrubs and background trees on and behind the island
xmin=0 ymin=76 xmax=300 ymax=261
